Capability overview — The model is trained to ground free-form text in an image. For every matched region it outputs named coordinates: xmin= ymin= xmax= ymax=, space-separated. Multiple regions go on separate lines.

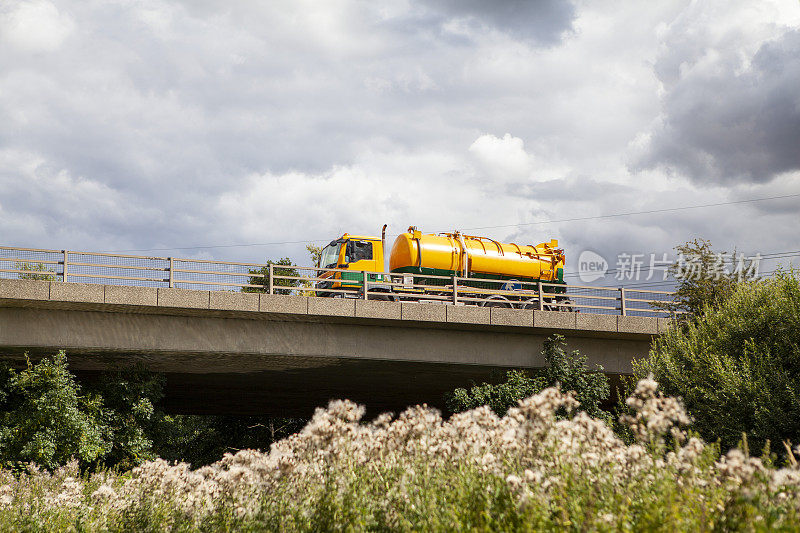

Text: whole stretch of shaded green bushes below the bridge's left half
xmin=0 ymin=352 xmax=305 ymax=470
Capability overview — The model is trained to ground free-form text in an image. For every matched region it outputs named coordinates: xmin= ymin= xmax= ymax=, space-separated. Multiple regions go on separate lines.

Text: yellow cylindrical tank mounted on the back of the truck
xmin=389 ymin=227 xmax=564 ymax=282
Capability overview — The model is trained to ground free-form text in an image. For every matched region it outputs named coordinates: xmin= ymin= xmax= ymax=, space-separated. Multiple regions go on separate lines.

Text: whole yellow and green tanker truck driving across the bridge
xmin=316 ymin=225 xmax=571 ymax=310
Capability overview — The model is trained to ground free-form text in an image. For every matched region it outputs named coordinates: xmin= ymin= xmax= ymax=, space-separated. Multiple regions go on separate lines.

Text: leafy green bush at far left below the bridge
xmin=0 ymin=351 xmax=111 ymax=468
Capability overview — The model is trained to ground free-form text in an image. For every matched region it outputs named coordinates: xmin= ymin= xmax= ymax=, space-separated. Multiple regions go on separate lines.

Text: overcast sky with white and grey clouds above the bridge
xmin=0 ymin=0 xmax=800 ymax=284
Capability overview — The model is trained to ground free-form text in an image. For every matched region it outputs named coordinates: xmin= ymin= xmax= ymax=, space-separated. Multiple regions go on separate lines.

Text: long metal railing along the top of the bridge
xmin=0 ymin=246 xmax=674 ymax=316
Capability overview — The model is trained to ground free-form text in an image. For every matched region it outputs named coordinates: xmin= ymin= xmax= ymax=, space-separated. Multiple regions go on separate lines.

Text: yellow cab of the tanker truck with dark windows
xmin=317 ymin=233 xmax=384 ymax=297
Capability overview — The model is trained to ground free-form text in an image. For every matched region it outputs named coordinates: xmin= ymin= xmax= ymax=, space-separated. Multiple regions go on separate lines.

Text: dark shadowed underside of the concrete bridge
xmin=6 ymin=350 xmax=536 ymax=417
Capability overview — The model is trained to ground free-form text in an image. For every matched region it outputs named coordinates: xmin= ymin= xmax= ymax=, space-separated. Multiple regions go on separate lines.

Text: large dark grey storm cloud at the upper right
xmin=635 ymin=30 xmax=800 ymax=183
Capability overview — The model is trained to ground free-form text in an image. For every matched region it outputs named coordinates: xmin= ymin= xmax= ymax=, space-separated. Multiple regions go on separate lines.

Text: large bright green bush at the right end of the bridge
xmin=634 ymin=272 xmax=800 ymax=449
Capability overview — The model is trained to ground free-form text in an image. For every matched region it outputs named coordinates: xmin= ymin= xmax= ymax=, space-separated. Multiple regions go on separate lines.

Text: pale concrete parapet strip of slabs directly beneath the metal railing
xmin=0 ymin=279 xmax=673 ymax=336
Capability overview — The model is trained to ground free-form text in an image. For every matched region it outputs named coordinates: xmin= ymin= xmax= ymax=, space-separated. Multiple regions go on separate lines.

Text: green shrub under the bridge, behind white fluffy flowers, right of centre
xmin=447 ymin=335 xmax=609 ymax=416
